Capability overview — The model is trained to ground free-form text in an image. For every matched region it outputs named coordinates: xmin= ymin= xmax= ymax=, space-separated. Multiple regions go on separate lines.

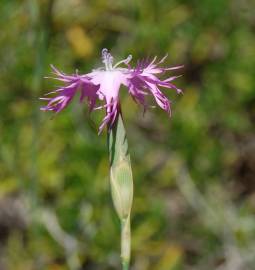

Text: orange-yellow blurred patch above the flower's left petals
xmin=66 ymin=25 xmax=94 ymax=58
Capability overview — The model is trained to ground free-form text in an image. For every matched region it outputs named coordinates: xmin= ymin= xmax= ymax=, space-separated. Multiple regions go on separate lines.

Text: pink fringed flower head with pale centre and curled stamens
xmin=41 ymin=49 xmax=182 ymax=133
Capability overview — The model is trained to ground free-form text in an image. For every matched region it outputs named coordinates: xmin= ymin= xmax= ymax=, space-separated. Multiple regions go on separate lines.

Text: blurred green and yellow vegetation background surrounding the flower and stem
xmin=0 ymin=0 xmax=255 ymax=270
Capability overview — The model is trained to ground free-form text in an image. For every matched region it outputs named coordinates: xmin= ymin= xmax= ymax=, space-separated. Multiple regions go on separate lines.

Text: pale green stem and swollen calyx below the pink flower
xmin=108 ymin=113 xmax=133 ymax=270
